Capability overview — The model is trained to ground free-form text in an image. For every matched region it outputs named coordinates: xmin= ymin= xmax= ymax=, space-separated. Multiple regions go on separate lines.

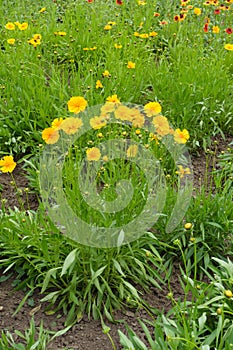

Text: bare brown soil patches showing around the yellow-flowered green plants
xmin=0 ymin=133 xmax=232 ymax=350
